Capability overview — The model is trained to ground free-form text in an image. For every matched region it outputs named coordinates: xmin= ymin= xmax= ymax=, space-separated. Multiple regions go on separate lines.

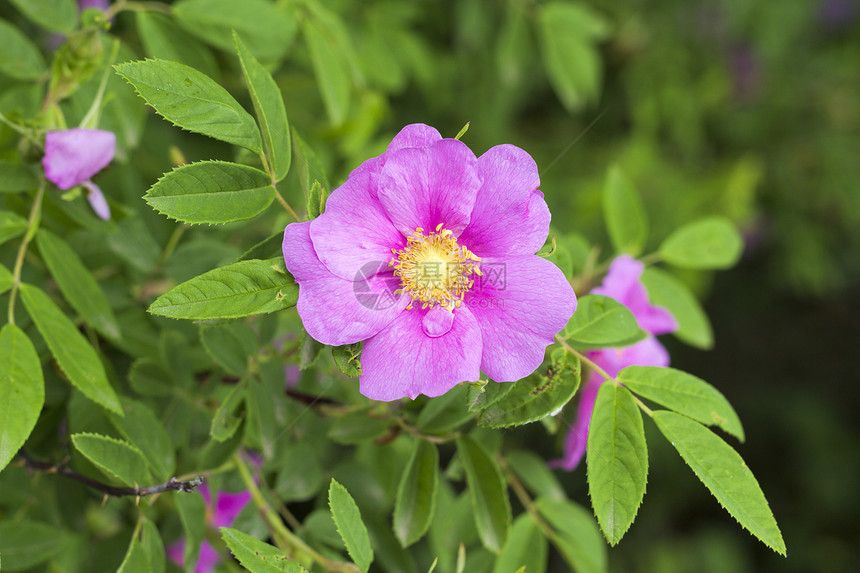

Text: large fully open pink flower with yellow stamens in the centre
xmin=283 ymin=124 xmax=576 ymax=400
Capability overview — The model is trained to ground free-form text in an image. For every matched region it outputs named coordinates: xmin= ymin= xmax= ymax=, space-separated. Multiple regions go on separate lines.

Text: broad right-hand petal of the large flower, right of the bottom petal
xmin=464 ymin=255 xmax=576 ymax=382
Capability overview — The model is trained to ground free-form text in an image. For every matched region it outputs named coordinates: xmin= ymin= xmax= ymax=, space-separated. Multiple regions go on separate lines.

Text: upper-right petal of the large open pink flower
xmin=460 ymin=145 xmax=550 ymax=257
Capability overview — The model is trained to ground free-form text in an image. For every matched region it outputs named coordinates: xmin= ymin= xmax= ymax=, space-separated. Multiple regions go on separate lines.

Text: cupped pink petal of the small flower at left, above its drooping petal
xmin=42 ymin=128 xmax=116 ymax=190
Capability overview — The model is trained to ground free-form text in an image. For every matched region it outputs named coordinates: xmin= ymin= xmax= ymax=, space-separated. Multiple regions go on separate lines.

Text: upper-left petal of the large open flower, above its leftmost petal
xmin=310 ymin=172 xmax=406 ymax=281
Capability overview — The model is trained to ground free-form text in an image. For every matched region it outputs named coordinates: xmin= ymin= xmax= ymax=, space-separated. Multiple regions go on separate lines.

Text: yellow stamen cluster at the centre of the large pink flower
xmin=388 ymin=223 xmax=481 ymax=310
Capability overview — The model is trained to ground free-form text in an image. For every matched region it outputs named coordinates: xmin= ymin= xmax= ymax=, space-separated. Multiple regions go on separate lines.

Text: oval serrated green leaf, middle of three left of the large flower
xmin=144 ymin=161 xmax=275 ymax=225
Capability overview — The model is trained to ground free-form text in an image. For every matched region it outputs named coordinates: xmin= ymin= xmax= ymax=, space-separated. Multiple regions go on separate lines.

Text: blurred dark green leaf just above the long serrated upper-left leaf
xmin=134 ymin=11 xmax=218 ymax=77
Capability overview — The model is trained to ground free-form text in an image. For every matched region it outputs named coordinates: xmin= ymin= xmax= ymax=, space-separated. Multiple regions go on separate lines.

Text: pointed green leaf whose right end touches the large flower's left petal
xmin=149 ymin=257 xmax=299 ymax=320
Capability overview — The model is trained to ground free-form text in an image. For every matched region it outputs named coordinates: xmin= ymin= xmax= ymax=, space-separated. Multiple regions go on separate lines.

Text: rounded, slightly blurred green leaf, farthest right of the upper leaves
xmin=658 ymin=217 xmax=744 ymax=269
